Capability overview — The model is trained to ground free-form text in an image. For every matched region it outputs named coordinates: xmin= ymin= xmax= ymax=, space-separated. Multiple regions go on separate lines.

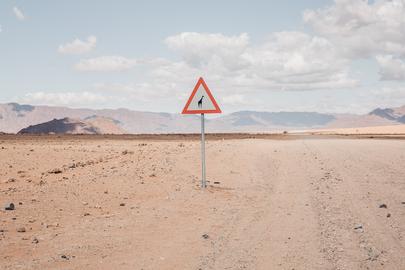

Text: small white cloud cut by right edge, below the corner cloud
xmin=376 ymin=55 xmax=405 ymax=80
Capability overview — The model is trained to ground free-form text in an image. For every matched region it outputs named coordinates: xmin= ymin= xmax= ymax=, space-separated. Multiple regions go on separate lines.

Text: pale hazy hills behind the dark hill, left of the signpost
xmin=0 ymin=103 xmax=200 ymax=134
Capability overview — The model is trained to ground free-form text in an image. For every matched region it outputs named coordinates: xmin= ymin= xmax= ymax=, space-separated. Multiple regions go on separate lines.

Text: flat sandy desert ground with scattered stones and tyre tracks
xmin=0 ymin=135 xmax=405 ymax=270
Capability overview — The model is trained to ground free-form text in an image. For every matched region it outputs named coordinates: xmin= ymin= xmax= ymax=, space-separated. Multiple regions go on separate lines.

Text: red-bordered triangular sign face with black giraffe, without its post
xmin=182 ymin=78 xmax=221 ymax=114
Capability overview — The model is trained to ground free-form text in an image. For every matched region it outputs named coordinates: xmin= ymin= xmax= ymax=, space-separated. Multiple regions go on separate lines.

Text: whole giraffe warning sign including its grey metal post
xmin=182 ymin=78 xmax=221 ymax=188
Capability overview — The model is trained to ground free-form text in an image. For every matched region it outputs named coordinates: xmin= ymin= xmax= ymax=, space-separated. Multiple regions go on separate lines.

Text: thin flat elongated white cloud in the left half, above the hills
xmin=75 ymin=56 xmax=137 ymax=71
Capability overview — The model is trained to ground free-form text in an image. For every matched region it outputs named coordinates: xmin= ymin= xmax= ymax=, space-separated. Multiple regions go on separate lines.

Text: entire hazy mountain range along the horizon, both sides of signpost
xmin=0 ymin=103 xmax=405 ymax=134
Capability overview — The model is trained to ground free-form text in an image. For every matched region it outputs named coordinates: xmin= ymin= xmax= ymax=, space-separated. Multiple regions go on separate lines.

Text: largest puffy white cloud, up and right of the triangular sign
xmin=244 ymin=32 xmax=356 ymax=90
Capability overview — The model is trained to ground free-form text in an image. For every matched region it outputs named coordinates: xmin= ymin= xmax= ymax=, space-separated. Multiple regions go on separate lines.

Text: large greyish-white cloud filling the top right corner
xmin=303 ymin=0 xmax=405 ymax=58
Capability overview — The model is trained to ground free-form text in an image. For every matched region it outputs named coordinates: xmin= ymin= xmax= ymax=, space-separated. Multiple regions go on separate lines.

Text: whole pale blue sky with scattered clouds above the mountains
xmin=0 ymin=0 xmax=405 ymax=114
